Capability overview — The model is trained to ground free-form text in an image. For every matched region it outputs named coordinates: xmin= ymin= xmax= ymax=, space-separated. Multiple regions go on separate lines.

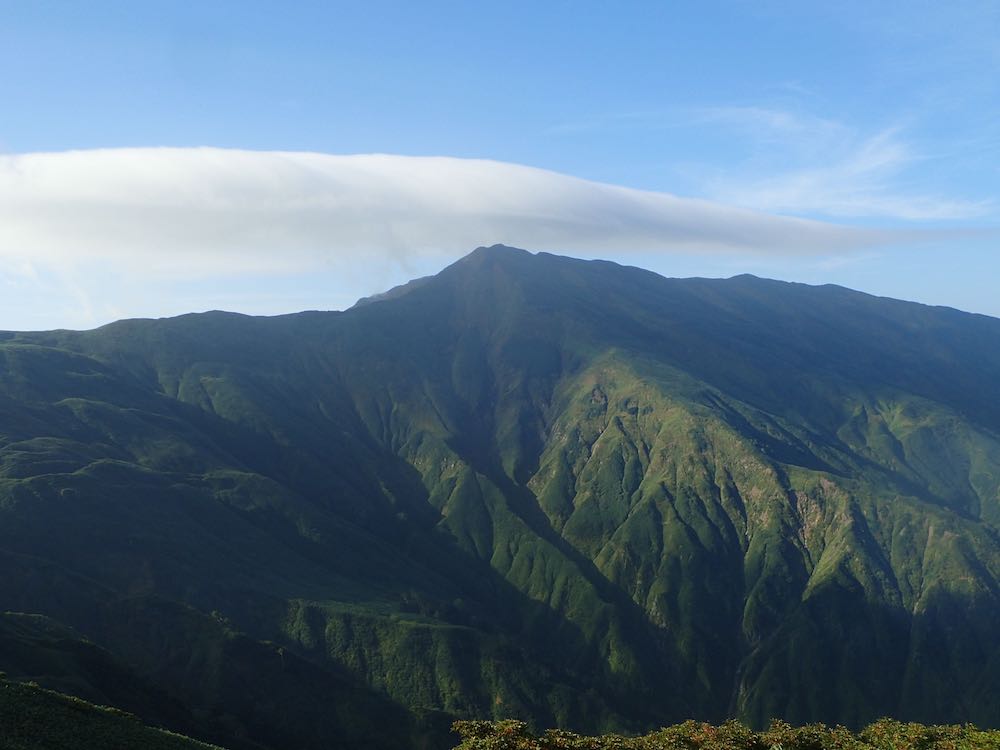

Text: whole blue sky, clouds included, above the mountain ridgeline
xmin=0 ymin=0 xmax=1000 ymax=329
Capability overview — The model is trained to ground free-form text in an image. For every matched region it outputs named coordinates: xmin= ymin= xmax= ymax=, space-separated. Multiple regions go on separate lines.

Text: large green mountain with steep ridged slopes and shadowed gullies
xmin=0 ymin=246 xmax=1000 ymax=750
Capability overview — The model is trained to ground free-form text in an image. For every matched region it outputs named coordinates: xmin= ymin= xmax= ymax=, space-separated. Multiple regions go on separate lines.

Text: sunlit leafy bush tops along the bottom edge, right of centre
xmin=452 ymin=719 xmax=1000 ymax=750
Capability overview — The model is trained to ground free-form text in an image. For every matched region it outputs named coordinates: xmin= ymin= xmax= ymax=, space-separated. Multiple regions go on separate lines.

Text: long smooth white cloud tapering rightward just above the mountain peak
xmin=0 ymin=148 xmax=898 ymax=278
